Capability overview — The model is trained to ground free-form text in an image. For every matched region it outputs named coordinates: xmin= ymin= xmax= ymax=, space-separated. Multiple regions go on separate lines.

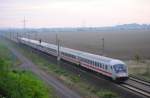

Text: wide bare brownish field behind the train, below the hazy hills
xmin=30 ymin=30 xmax=150 ymax=60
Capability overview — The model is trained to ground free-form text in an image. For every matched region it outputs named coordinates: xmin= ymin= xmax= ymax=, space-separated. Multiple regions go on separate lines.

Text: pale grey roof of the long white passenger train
xmin=21 ymin=38 xmax=124 ymax=65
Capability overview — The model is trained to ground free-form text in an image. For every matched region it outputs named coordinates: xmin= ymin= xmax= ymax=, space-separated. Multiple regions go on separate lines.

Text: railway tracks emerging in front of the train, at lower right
xmin=120 ymin=76 xmax=150 ymax=98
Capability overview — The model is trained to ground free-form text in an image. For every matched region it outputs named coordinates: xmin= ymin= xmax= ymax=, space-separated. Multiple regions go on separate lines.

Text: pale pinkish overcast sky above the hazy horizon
xmin=0 ymin=0 xmax=150 ymax=28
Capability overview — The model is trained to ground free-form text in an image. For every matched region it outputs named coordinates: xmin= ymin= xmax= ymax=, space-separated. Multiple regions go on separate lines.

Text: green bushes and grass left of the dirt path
xmin=0 ymin=39 xmax=54 ymax=98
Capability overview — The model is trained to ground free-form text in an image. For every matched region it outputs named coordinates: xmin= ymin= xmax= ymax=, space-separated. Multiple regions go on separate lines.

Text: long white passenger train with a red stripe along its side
xmin=19 ymin=37 xmax=128 ymax=81
